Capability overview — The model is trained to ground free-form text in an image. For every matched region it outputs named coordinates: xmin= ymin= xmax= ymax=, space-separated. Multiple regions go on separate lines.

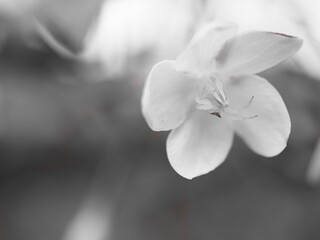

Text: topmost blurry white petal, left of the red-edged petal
xmin=176 ymin=21 xmax=237 ymax=73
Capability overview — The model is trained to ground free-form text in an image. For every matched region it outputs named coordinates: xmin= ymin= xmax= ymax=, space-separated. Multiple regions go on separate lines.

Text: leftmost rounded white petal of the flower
xmin=142 ymin=60 xmax=196 ymax=131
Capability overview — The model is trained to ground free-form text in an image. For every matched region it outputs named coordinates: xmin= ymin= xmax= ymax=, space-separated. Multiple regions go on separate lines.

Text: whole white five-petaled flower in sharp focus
xmin=142 ymin=22 xmax=302 ymax=179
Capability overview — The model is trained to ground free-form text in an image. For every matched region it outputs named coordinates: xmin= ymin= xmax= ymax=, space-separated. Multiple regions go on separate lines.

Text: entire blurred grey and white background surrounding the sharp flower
xmin=0 ymin=0 xmax=320 ymax=240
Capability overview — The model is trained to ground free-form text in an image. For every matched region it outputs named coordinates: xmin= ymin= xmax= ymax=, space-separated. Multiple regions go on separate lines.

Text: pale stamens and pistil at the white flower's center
xmin=196 ymin=77 xmax=258 ymax=120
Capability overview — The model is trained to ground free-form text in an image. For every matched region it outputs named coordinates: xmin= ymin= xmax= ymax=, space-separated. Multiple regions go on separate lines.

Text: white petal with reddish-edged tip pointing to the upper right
xmin=217 ymin=31 xmax=302 ymax=75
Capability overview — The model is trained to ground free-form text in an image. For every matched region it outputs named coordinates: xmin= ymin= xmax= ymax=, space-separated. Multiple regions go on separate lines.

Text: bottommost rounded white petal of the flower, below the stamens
xmin=167 ymin=110 xmax=233 ymax=179
